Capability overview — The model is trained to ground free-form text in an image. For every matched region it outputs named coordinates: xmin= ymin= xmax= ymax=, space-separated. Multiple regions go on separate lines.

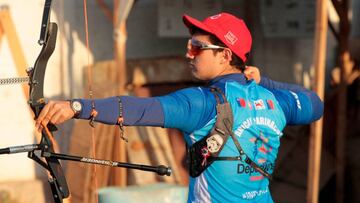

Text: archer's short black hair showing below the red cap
xmin=190 ymin=27 xmax=250 ymax=72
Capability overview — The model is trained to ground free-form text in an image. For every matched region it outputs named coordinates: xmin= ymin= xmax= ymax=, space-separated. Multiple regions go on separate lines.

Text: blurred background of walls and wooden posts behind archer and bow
xmin=0 ymin=0 xmax=360 ymax=203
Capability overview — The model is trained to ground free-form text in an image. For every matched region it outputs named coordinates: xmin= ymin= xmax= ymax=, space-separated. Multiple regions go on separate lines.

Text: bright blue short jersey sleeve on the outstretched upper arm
xmin=159 ymin=88 xmax=216 ymax=133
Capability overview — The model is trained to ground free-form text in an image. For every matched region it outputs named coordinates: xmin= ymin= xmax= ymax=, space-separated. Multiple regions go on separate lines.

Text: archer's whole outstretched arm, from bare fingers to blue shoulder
xmin=36 ymin=88 xmax=215 ymax=132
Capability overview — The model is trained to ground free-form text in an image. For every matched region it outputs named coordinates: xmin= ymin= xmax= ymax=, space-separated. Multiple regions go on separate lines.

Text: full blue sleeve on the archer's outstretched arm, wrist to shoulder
xmin=79 ymin=88 xmax=216 ymax=132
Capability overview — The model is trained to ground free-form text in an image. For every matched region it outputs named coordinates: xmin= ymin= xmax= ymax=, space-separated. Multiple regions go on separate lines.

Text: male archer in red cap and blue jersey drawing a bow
xmin=36 ymin=13 xmax=323 ymax=202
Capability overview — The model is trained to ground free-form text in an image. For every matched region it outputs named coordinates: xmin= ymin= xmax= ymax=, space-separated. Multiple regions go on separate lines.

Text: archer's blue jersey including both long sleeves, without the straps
xmin=76 ymin=74 xmax=323 ymax=202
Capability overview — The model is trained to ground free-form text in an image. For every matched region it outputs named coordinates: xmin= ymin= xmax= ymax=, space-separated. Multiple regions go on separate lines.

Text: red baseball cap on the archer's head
xmin=183 ymin=13 xmax=252 ymax=62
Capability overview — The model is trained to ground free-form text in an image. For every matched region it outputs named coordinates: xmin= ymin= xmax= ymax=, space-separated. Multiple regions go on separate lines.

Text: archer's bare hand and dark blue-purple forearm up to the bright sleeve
xmin=36 ymin=96 xmax=164 ymax=131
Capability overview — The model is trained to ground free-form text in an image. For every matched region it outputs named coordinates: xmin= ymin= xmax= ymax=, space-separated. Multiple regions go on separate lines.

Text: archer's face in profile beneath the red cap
xmin=186 ymin=34 xmax=223 ymax=81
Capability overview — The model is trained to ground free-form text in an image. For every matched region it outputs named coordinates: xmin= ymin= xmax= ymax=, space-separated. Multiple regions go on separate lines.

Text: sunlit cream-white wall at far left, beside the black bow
xmin=0 ymin=0 xmax=41 ymax=181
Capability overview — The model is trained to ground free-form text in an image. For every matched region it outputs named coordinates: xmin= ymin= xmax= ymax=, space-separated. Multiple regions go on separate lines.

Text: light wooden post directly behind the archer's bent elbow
xmin=306 ymin=0 xmax=328 ymax=203
